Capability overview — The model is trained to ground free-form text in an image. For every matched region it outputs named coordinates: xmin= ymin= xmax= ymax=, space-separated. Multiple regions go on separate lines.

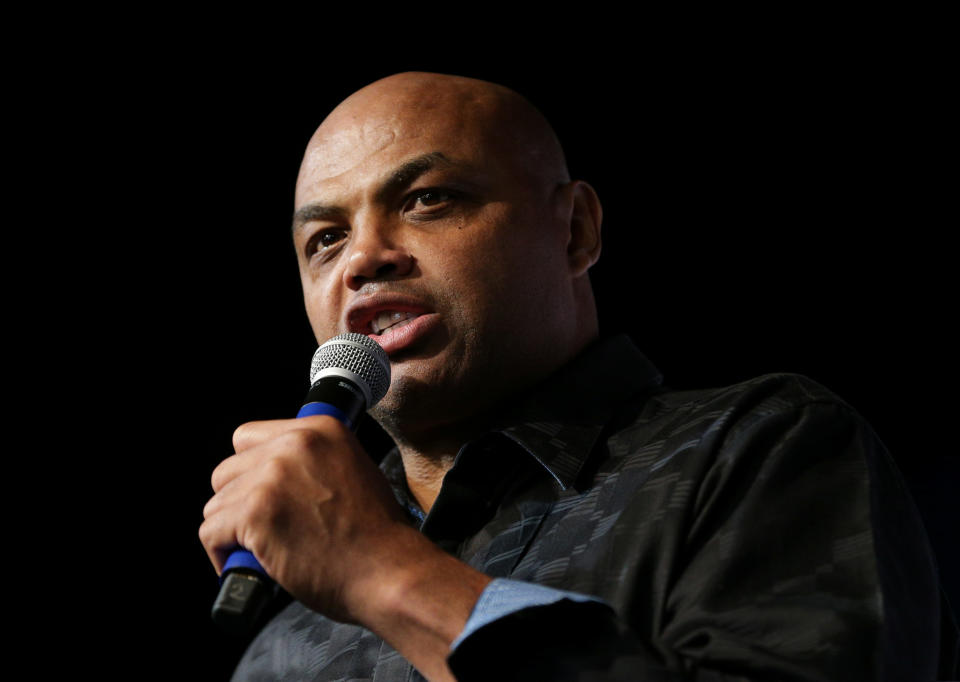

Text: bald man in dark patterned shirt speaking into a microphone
xmin=200 ymin=73 xmax=953 ymax=680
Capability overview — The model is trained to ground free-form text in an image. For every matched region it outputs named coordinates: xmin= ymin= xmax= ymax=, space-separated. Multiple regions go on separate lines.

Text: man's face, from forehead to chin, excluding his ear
xmin=294 ymin=78 xmax=575 ymax=428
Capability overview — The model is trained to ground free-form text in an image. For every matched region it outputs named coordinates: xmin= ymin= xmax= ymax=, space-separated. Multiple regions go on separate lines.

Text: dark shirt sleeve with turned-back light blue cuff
xmin=449 ymin=396 xmax=956 ymax=682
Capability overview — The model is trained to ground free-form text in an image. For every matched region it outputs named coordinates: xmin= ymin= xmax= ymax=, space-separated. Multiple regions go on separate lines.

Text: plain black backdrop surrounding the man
xmin=22 ymin=17 xmax=960 ymax=679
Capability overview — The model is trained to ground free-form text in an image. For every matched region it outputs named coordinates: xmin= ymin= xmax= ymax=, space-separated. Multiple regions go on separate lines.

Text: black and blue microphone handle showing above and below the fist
xmin=210 ymin=376 xmax=366 ymax=635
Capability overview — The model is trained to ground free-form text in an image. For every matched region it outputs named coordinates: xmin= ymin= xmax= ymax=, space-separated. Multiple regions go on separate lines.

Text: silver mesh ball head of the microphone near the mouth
xmin=310 ymin=333 xmax=390 ymax=409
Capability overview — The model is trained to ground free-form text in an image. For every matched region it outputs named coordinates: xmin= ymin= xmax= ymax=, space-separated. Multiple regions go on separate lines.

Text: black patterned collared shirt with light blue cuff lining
xmin=234 ymin=337 xmax=957 ymax=682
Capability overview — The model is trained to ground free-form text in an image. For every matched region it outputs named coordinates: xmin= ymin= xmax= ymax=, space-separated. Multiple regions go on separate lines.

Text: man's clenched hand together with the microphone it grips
xmin=200 ymin=334 xmax=402 ymax=633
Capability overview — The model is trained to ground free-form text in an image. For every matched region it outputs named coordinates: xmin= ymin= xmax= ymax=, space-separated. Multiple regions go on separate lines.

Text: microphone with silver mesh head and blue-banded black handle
xmin=211 ymin=333 xmax=390 ymax=635
